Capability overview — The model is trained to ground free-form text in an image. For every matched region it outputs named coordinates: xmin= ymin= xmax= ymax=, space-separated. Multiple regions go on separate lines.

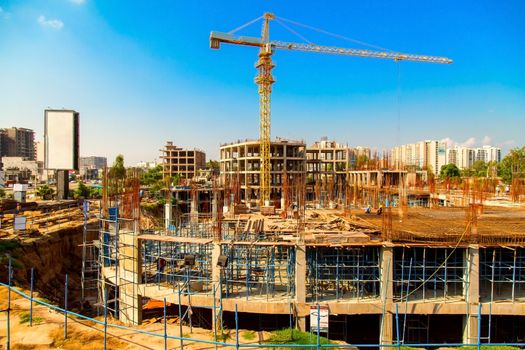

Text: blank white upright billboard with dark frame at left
xmin=44 ymin=110 xmax=79 ymax=170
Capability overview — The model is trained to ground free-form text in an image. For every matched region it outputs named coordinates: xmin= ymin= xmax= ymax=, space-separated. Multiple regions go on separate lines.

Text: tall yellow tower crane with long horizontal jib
xmin=210 ymin=12 xmax=452 ymax=206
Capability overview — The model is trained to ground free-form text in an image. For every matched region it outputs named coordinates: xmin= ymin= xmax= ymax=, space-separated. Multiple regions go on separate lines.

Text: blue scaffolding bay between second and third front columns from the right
xmin=306 ymin=247 xmax=380 ymax=302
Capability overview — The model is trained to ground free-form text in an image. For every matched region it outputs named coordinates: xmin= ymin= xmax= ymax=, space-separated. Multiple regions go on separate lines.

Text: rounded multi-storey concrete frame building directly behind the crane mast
xmin=220 ymin=138 xmax=306 ymax=206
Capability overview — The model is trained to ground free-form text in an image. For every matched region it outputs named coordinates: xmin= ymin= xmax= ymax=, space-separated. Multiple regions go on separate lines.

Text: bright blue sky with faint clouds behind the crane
xmin=0 ymin=0 xmax=525 ymax=164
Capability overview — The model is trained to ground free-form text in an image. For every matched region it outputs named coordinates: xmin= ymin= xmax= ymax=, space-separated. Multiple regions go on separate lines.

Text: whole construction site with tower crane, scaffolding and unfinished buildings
xmin=0 ymin=13 xmax=525 ymax=349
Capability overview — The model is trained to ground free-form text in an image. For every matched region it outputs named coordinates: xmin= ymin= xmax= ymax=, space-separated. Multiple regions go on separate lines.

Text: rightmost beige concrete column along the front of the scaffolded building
xmin=463 ymin=244 xmax=479 ymax=344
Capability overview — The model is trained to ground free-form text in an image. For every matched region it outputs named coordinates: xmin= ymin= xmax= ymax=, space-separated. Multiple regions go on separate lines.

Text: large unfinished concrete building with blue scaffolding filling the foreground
xmin=83 ymin=168 xmax=525 ymax=344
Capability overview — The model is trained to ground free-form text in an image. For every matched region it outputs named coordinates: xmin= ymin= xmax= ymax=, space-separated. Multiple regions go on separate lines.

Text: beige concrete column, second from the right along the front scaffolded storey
xmin=379 ymin=246 xmax=394 ymax=344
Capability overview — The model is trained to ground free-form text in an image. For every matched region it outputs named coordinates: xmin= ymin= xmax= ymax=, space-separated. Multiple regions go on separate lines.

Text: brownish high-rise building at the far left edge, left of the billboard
xmin=0 ymin=127 xmax=36 ymax=160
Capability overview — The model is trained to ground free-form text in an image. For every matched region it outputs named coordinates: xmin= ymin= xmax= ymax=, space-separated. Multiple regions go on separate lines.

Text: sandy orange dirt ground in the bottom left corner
xmin=0 ymin=287 xmax=268 ymax=350
